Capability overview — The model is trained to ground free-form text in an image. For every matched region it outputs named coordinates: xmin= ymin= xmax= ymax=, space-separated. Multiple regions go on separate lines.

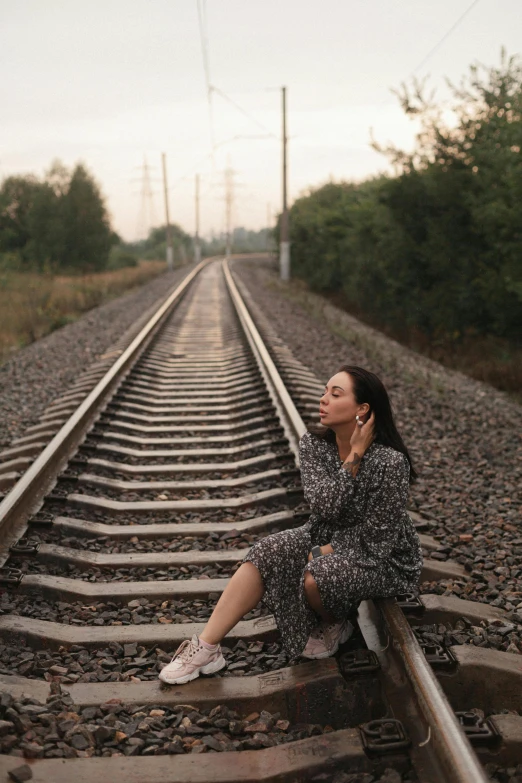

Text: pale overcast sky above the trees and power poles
xmin=0 ymin=0 xmax=522 ymax=239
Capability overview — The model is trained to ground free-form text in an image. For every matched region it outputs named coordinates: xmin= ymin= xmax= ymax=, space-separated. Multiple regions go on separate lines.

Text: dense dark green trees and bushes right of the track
xmin=280 ymin=52 xmax=522 ymax=341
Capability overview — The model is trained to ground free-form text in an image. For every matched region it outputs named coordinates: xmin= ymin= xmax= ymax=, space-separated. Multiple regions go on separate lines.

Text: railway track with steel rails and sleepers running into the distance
xmin=0 ymin=261 xmax=522 ymax=783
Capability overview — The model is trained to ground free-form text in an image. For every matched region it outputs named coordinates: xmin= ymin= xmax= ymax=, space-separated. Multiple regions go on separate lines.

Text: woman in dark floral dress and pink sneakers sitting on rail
xmin=159 ymin=365 xmax=422 ymax=685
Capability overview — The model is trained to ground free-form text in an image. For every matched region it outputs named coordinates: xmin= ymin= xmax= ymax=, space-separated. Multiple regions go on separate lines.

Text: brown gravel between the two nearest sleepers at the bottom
xmin=0 ymin=686 xmax=333 ymax=759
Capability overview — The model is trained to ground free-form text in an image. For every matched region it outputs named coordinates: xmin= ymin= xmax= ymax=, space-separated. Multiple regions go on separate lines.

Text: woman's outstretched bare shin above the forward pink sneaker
xmin=199 ymin=561 xmax=265 ymax=644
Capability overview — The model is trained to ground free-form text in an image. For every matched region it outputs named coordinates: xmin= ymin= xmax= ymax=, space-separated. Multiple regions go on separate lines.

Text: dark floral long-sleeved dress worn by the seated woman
xmin=245 ymin=432 xmax=422 ymax=657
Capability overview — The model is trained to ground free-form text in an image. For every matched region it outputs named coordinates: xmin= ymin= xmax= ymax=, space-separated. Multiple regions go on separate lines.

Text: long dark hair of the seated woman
xmin=309 ymin=364 xmax=417 ymax=484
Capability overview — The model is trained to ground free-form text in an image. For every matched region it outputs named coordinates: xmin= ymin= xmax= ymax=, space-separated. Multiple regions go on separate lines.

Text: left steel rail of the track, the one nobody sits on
xmin=0 ymin=259 xmax=215 ymax=565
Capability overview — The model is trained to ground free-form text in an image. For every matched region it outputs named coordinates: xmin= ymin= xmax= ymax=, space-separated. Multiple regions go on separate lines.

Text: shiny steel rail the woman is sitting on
xmin=223 ymin=261 xmax=488 ymax=783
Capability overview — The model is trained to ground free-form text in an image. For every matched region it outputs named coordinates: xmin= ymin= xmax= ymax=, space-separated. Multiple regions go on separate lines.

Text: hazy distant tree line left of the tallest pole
xmin=0 ymin=161 xmax=270 ymax=274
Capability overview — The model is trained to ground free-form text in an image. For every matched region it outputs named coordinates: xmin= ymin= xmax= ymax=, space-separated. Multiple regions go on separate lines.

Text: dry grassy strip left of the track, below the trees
xmin=0 ymin=261 xmax=165 ymax=364
